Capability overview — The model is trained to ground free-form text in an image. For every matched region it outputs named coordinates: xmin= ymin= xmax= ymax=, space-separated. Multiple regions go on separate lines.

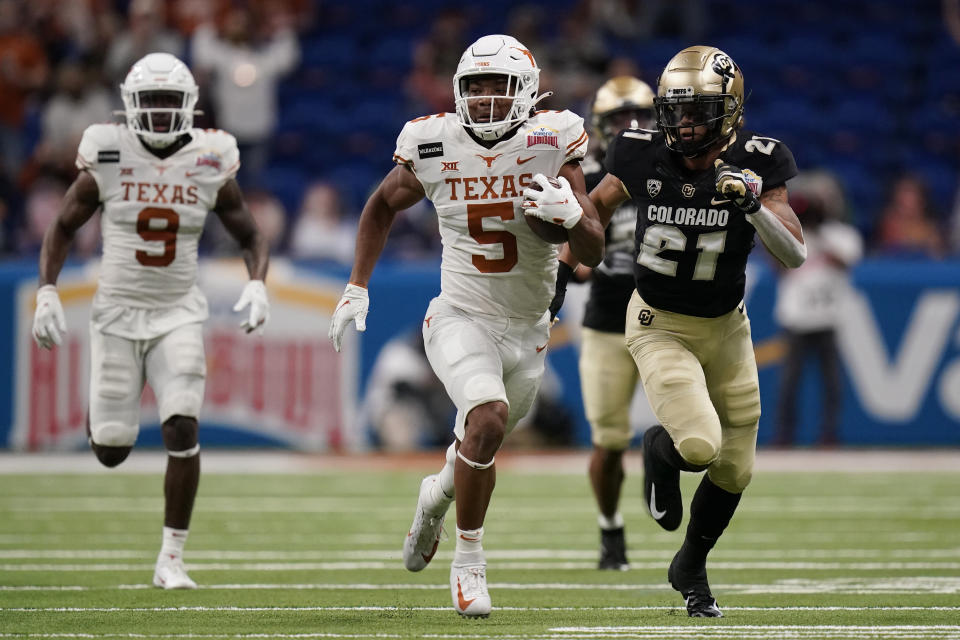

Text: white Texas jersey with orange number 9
xmin=77 ymin=124 xmax=240 ymax=338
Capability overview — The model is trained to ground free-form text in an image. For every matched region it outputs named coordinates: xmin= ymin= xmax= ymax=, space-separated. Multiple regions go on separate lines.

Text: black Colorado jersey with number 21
xmin=604 ymin=130 xmax=797 ymax=318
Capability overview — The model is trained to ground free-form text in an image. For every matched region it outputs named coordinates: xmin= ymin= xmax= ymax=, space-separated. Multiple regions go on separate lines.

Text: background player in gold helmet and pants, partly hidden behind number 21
xmin=550 ymin=76 xmax=654 ymax=570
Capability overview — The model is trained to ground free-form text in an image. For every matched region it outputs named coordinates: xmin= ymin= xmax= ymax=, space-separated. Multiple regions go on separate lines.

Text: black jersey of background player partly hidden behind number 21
xmin=583 ymin=156 xmax=637 ymax=333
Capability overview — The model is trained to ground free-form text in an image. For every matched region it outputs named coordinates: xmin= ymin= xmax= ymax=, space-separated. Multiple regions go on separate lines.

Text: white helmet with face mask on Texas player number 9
xmin=120 ymin=53 xmax=198 ymax=148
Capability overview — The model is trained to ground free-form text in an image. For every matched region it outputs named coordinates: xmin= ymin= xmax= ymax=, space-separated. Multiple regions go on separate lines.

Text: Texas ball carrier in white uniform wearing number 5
xmin=330 ymin=35 xmax=603 ymax=617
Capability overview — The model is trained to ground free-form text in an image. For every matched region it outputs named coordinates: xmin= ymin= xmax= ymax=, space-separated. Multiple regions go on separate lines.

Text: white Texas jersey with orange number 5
xmin=393 ymin=111 xmax=587 ymax=319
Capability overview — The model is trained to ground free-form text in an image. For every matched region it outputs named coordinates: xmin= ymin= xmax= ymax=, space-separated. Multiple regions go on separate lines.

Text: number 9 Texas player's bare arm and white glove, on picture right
xmin=213 ymin=178 xmax=270 ymax=333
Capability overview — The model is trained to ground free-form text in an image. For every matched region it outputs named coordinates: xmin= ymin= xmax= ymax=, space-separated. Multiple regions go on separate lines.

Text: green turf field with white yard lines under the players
xmin=0 ymin=462 xmax=960 ymax=640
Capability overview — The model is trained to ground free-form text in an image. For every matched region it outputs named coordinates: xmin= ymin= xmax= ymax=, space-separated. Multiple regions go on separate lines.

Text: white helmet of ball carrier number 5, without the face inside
xmin=453 ymin=34 xmax=550 ymax=140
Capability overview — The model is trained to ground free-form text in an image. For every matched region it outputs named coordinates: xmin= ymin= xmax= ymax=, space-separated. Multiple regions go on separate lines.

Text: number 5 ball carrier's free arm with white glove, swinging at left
xmin=327 ymin=165 xmax=426 ymax=351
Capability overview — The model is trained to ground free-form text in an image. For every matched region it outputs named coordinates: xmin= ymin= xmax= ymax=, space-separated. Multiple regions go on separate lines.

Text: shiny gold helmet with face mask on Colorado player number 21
xmin=654 ymin=47 xmax=743 ymax=157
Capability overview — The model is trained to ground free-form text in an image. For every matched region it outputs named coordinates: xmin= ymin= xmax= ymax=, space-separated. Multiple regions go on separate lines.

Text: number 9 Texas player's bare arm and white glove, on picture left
xmin=32 ymin=171 xmax=100 ymax=349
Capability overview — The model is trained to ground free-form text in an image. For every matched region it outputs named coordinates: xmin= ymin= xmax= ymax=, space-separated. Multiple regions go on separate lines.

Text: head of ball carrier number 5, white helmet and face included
xmin=453 ymin=35 xmax=540 ymax=141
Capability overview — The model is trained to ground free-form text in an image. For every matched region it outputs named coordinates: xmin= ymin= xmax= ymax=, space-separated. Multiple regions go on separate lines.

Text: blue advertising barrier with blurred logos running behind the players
xmin=0 ymin=260 xmax=960 ymax=451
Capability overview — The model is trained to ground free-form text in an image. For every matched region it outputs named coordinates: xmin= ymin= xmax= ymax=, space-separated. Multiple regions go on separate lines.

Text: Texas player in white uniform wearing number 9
xmin=33 ymin=53 xmax=269 ymax=589
